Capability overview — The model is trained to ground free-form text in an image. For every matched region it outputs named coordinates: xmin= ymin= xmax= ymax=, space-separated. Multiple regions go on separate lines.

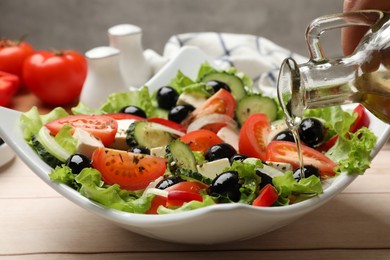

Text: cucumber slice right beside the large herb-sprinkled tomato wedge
xmin=167 ymin=139 xmax=197 ymax=172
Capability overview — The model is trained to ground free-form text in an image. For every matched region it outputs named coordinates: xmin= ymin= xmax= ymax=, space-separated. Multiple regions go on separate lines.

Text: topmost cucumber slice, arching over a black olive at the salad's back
xmin=201 ymin=72 xmax=246 ymax=100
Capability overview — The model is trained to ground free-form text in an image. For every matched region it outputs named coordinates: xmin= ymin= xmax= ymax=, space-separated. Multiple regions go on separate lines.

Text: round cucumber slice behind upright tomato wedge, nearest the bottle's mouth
xmin=236 ymin=94 xmax=278 ymax=125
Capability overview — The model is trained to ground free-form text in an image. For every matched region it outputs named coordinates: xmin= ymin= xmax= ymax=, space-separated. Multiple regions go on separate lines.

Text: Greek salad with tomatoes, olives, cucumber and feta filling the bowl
xmin=20 ymin=63 xmax=376 ymax=214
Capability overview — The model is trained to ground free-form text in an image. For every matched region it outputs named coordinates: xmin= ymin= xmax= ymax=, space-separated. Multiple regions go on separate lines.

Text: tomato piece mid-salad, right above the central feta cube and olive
xmin=180 ymin=129 xmax=223 ymax=153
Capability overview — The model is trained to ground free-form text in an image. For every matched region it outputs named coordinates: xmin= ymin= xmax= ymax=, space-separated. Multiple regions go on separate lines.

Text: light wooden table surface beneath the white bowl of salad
xmin=0 ymin=90 xmax=390 ymax=259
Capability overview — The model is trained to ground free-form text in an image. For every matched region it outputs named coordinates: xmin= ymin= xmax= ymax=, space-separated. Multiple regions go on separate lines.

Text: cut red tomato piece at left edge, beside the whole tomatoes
xmin=0 ymin=71 xmax=20 ymax=106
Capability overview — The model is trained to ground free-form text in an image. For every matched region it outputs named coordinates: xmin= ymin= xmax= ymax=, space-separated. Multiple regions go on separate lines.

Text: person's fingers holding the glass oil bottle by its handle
xmin=341 ymin=0 xmax=390 ymax=55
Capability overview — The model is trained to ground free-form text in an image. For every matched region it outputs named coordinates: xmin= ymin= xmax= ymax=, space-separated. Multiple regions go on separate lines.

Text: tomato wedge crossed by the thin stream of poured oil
xmin=266 ymin=141 xmax=336 ymax=175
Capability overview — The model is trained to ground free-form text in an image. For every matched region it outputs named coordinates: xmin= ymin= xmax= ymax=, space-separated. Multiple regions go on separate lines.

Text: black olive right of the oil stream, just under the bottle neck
xmin=298 ymin=118 xmax=325 ymax=147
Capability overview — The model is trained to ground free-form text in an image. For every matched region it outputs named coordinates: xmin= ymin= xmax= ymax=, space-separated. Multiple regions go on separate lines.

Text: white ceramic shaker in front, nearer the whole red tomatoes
xmin=80 ymin=46 xmax=128 ymax=108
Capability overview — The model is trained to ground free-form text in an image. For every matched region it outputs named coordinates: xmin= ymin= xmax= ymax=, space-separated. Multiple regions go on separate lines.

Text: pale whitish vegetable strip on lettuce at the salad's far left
xmin=37 ymin=126 xmax=71 ymax=162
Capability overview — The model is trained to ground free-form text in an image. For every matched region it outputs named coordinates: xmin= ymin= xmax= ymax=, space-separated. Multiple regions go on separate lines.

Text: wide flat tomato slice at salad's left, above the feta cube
xmin=45 ymin=115 xmax=118 ymax=146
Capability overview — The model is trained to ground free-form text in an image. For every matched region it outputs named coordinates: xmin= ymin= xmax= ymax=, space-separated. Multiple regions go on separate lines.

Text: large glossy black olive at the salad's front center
xmin=208 ymin=171 xmax=241 ymax=202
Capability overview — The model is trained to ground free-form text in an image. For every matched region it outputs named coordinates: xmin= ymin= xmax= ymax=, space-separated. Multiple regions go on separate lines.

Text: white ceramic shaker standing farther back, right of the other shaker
xmin=108 ymin=24 xmax=152 ymax=87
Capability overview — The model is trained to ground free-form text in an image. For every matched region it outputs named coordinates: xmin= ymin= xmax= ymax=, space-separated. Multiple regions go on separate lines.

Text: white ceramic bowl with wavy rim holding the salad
xmin=0 ymin=48 xmax=390 ymax=244
